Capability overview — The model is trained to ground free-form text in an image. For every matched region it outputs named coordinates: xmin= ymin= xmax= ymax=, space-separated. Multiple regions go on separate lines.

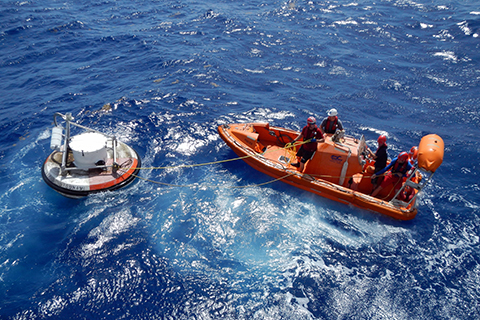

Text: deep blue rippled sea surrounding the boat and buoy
xmin=0 ymin=0 xmax=480 ymax=320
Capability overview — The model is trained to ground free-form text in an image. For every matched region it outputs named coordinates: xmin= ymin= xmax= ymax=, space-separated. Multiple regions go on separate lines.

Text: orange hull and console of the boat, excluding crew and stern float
xmin=218 ymin=123 xmax=417 ymax=220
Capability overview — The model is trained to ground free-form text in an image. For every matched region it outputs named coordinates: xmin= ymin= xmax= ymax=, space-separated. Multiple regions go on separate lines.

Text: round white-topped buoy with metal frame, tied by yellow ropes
xmin=42 ymin=113 xmax=141 ymax=198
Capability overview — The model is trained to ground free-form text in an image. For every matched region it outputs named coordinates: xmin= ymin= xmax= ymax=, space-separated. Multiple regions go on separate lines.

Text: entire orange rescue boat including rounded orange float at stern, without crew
xmin=218 ymin=123 xmax=444 ymax=220
